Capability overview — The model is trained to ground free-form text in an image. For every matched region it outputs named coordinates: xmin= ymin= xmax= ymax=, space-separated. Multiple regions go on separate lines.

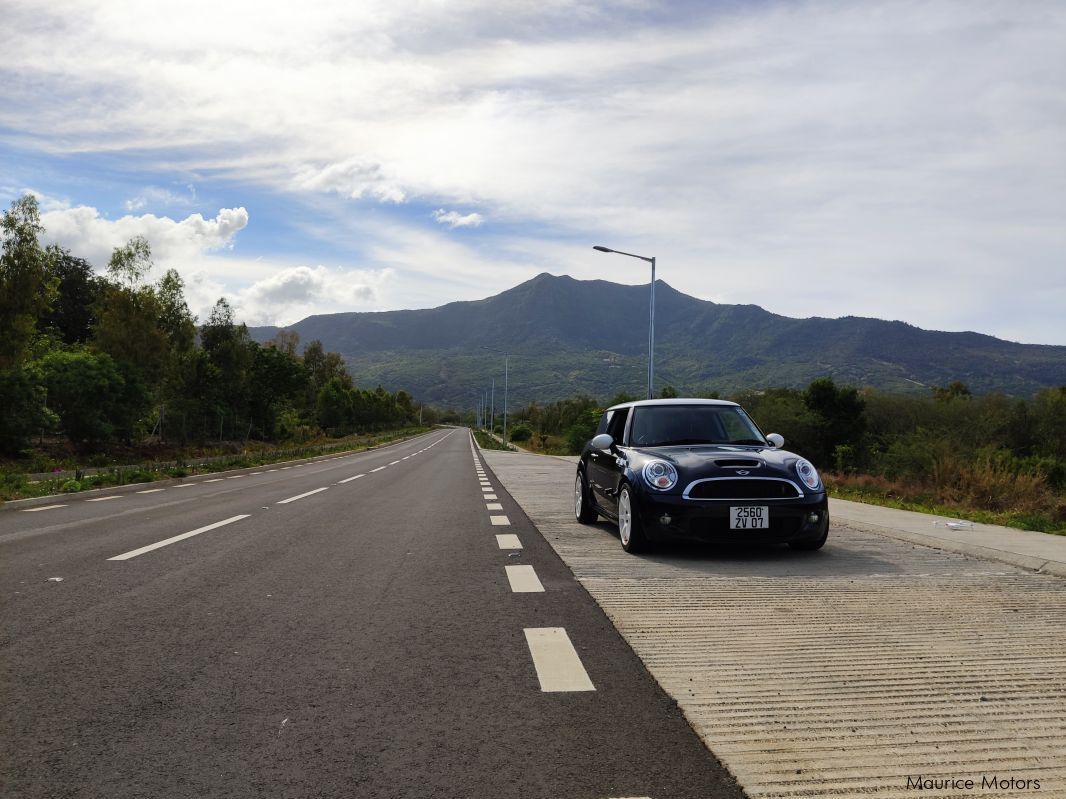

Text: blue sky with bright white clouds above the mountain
xmin=0 ymin=0 xmax=1066 ymax=345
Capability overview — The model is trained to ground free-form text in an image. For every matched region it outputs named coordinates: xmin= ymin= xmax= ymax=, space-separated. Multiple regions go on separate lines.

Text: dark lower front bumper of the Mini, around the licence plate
xmin=634 ymin=492 xmax=829 ymax=543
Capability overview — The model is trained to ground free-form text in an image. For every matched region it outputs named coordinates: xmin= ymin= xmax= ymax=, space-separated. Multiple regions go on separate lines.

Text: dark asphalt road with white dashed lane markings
xmin=0 ymin=430 xmax=742 ymax=799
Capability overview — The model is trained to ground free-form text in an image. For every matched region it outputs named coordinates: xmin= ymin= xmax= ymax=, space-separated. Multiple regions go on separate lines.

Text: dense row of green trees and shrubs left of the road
xmin=0 ymin=195 xmax=438 ymax=499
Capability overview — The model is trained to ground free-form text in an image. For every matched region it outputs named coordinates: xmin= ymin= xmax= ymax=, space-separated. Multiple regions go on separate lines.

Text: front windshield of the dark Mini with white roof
xmin=629 ymin=405 xmax=766 ymax=446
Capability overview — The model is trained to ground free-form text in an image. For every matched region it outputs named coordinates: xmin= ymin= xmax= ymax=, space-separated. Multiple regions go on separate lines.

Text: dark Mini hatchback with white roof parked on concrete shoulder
xmin=574 ymin=400 xmax=829 ymax=552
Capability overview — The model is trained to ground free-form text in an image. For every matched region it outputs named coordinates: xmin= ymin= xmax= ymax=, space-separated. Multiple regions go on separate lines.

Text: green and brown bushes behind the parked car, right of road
xmin=503 ymin=377 xmax=1066 ymax=535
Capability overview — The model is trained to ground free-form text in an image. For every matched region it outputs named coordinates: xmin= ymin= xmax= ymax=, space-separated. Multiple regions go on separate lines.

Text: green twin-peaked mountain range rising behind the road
xmin=251 ymin=274 xmax=1066 ymax=407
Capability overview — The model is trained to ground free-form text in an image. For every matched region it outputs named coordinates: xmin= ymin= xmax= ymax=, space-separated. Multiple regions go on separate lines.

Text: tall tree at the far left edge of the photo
xmin=0 ymin=194 xmax=59 ymax=370
